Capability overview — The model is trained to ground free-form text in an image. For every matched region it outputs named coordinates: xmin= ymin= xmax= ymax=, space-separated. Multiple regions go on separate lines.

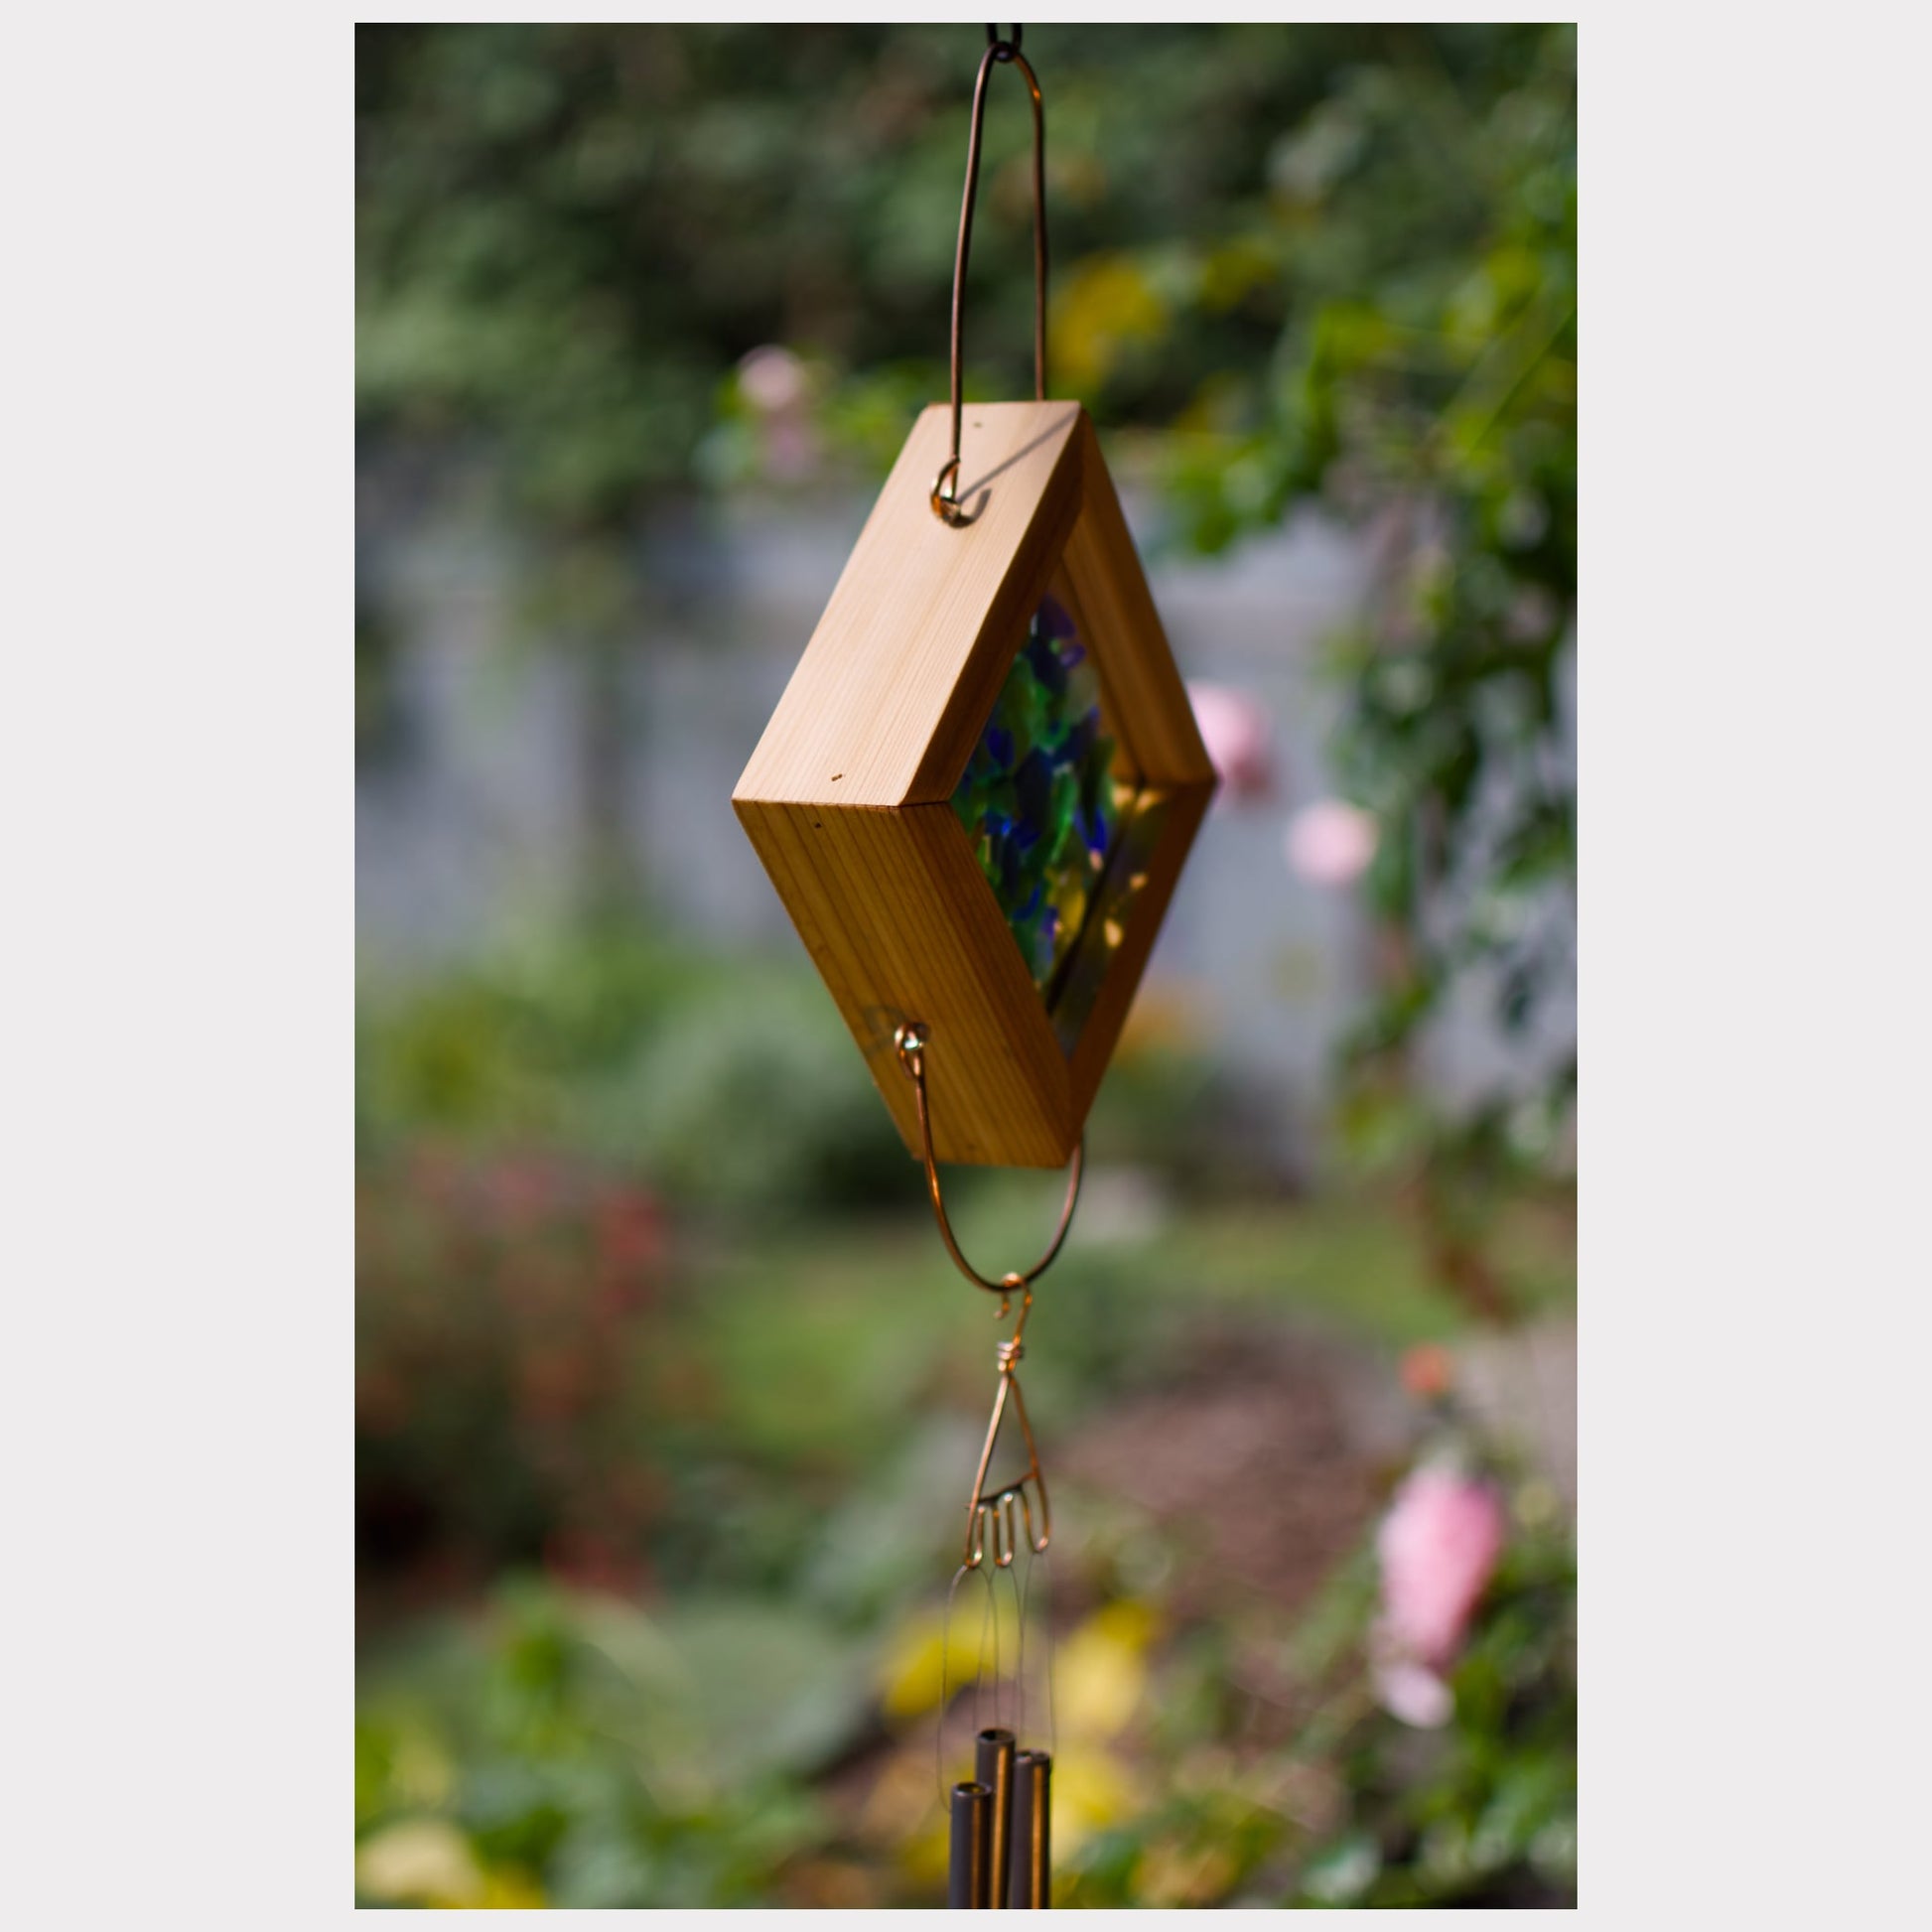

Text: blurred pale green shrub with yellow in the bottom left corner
xmin=355 ymin=1587 xmax=868 ymax=1907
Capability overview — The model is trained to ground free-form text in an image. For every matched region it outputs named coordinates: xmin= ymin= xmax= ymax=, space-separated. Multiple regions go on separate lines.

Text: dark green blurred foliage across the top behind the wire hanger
xmin=357 ymin=23 xmax=1575 ymax=486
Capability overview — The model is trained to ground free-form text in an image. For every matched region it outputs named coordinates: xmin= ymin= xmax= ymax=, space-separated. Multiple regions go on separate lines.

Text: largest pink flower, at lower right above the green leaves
xmin=1376 ymin=1468 xmax=1503 ymax=1671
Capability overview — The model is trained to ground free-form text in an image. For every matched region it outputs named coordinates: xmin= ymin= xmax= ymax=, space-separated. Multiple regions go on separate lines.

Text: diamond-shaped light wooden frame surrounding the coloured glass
xmin=733 ymin=402 xmax=1215 ymax=1167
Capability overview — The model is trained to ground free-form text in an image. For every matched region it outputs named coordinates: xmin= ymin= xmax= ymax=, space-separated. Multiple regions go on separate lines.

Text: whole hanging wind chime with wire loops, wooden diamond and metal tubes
xmin=733 ymin=27 xmax=1215 ymax=1907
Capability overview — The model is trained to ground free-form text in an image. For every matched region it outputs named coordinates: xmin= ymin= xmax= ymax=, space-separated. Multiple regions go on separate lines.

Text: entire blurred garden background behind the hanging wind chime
xmin=355 ymin=25 xmax=1577 ymax=1907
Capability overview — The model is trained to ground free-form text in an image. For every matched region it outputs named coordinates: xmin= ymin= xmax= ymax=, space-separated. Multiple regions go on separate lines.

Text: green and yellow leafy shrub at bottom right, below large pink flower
xmin=1055 ymin=1491 xmax=1577 ymax=1907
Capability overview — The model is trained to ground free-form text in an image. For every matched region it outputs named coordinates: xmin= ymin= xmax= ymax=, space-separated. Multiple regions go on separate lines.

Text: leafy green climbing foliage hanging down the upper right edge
xmin=1146 ymin=27 xmax=1577 ymax=1162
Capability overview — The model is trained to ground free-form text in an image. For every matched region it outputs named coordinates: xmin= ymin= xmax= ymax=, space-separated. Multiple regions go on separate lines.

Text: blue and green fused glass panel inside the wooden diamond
xmin=952 ymin=586 xmax=1134 ymax=1045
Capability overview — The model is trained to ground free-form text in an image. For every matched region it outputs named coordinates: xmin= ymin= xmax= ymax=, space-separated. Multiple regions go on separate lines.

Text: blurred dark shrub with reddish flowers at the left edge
xmin=355 ymin=1142 xmax=664 ymax=1583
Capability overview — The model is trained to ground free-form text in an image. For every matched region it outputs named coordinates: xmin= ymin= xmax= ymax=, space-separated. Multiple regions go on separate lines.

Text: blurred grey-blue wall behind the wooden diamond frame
xmin=355 ymin=466 xmax=1573 ymax=1127
